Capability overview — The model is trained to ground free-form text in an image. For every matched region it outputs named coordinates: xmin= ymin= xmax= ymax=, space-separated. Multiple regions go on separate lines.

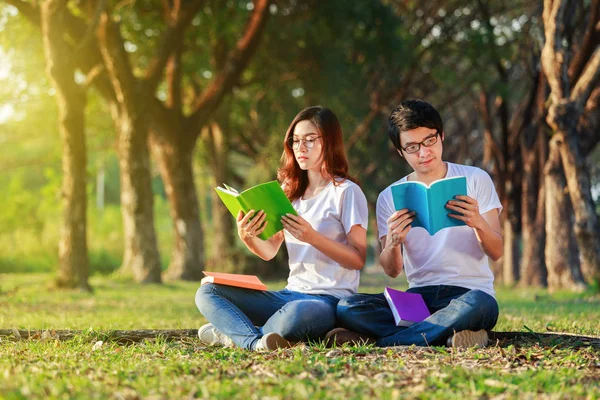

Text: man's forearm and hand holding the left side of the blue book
xmin=379 ymin=209 xmax=415 ymax=278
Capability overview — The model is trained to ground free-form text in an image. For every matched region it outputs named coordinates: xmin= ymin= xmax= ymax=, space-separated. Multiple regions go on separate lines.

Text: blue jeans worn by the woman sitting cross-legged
xmin=196 ymin=283 xmax=339 ymax=349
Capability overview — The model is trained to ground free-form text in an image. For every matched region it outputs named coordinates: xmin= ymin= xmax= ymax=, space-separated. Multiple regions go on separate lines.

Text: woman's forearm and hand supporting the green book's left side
xmin=237 ymin=210 xmax=284 ymax=261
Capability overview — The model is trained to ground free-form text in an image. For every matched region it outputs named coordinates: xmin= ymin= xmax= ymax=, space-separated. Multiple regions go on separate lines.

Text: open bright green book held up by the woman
xmin=215 ymin=181 xmax=298 ymax=240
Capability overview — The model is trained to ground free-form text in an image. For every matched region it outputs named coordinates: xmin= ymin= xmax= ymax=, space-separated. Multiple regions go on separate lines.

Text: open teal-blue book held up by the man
xmin=391 ymin=176 xmax=467 ymax=235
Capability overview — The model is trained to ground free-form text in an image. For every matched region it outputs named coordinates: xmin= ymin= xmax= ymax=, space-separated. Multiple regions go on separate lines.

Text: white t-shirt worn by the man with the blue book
xmin=377 ymin=163 xmax=502 ymax=296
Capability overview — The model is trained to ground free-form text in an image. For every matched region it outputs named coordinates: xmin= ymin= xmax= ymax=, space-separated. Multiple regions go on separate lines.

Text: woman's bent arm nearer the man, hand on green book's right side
xmin=281 ymin=214 xmax=367 ymax=270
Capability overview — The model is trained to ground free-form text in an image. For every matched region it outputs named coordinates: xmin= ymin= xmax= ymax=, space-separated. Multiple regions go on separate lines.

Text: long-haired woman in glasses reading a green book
xmin=196 ymin=106 xmax=368 ymax=350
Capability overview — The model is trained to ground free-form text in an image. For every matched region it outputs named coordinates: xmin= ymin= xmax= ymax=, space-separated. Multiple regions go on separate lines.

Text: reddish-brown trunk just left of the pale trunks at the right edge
xmin=520 ymin=129 xmax=548 ymax=286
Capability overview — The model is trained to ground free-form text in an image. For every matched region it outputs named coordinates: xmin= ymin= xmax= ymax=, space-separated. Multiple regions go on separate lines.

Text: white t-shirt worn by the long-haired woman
xmin=284 ymin=178 xmax=369 ymax=298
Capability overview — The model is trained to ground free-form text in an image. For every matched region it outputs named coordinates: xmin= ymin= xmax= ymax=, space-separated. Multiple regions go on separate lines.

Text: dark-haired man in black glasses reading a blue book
xmin=329 ymin=100 xmax=503 ymax=347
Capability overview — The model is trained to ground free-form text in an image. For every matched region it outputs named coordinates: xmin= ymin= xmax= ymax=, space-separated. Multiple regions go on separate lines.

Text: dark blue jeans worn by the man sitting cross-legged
xmin=337 ymin=285 xmax=499 ymax=347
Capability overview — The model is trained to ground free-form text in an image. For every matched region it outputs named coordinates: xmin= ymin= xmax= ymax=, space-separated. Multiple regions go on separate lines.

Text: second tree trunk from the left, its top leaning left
xmin=98 ymin=12 xmax=161 ymax=283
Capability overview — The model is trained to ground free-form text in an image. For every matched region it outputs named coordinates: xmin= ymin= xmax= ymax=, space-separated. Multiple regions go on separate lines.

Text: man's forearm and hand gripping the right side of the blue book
xmin=446 ymin=196 xmax=504 ymax=261
